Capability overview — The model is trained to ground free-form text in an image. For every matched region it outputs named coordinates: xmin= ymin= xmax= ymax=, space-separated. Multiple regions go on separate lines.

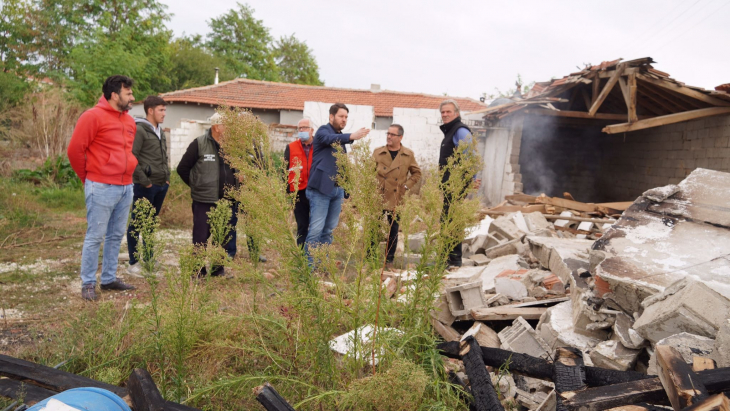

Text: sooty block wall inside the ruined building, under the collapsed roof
xmin=598 ymin=116 xmax=730 ymax=201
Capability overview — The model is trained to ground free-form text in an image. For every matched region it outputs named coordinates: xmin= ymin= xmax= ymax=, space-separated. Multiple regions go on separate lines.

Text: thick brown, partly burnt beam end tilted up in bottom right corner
xmin=655 ymin=345 xmax=709 ymax=411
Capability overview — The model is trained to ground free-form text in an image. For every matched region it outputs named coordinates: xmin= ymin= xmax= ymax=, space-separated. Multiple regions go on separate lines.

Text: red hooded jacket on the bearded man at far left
xmin=68 ymin=96 xmax=137 ymax=185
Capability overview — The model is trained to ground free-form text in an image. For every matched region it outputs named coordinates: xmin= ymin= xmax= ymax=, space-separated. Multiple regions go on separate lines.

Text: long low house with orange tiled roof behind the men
xmin=131 ymin=78 xmax=487 ymax=171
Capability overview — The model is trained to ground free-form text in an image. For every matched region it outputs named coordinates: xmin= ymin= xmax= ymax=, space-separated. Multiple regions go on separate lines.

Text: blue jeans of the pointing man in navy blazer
xmin=304 ymin=187 xmax=345 ymax=264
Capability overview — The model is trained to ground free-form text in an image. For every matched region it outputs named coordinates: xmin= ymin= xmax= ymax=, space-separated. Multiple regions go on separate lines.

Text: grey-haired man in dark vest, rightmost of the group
xmin=439 ymin=100 xmax=481 ymax=267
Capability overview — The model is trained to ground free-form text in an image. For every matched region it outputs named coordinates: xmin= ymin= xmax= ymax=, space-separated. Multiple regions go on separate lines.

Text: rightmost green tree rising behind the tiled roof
xmin=274 ymin=34 xmax=324 ymax=86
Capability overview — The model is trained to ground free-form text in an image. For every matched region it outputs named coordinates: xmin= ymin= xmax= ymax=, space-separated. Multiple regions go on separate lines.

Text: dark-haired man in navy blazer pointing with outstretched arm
xmin=304 ymin=103 xmax=370 ymax=264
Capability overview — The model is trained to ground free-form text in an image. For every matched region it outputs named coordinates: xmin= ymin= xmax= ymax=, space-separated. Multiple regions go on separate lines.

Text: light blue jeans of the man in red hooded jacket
xmin=81 ymin=180 xmax=133 ymax=285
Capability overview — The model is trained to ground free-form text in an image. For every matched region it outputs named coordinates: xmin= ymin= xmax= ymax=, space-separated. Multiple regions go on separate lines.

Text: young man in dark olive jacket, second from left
xmin=127 ymin=96 xmax=170 ymax=275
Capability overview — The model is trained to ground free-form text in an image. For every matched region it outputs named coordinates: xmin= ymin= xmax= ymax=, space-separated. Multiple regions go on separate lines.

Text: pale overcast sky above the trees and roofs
xmin=162 ymin=0 xmax=730 ymax=98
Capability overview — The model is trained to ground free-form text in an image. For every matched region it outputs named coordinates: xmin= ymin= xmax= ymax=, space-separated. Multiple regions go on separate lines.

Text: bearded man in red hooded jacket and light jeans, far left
xmin=68 ymin=76 xmax=137 ymax=300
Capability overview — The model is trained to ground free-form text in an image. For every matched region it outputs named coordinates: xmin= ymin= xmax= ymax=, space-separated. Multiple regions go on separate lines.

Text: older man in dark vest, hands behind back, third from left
xmin=177 ymin=113 xmax=253 ymax=277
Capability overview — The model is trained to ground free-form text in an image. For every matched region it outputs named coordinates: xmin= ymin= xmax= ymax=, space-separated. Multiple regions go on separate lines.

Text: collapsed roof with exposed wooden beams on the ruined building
xmin=472 ymin=57 xmax=730 ymax=134
